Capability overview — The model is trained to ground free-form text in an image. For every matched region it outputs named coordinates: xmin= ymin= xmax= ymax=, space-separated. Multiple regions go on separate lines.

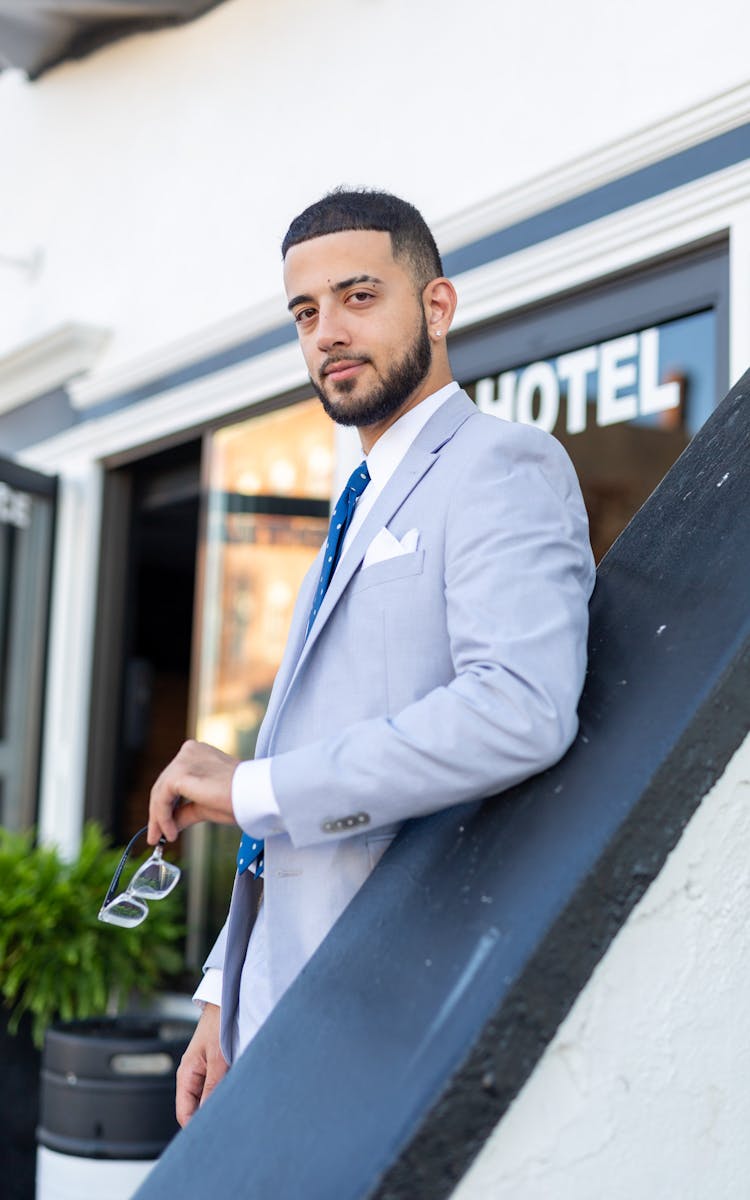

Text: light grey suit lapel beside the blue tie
xmin=258 ymin=391 xmax=476 ymax=757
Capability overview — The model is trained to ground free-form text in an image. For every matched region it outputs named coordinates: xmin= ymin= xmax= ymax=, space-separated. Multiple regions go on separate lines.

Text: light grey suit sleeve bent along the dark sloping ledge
xmin=266 ymin=427 xmax=594 ymax=847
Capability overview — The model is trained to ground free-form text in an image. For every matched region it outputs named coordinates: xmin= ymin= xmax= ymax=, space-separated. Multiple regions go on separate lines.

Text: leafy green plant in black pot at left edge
xmin=0 ymin=824 xmax=184 ymax=1198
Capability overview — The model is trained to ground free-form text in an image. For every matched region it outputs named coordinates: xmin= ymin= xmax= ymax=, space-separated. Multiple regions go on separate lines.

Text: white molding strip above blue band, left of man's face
xmin=68 ymin=292 xmax=289 ymax=409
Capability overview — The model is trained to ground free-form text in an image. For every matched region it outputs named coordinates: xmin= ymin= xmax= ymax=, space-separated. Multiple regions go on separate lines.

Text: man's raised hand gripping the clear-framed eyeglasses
xmin=148 ymin=742 xmax=239 ymax=846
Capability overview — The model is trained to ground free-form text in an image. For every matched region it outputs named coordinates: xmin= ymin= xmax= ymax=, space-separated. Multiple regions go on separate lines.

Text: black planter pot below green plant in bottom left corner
xmin=0 ymin=1009 xmax=41 ymax=1200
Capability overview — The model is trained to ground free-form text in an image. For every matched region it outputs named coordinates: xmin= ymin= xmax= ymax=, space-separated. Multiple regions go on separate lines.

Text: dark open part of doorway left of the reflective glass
xmin=86 ymin=440 xmax=200 ymax=842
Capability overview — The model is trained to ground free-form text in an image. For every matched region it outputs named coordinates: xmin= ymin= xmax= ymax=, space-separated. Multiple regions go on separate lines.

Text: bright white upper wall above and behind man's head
xmin=0 ymin=0 xmax=748 ymax=368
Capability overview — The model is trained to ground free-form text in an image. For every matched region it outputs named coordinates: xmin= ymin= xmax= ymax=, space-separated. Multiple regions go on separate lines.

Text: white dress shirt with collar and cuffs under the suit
xmin=193 ymin=383 xmax=458 ymax=1056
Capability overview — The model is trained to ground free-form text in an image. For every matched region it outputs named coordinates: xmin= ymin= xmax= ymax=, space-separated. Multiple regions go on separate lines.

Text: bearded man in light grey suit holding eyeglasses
xmin=149 ymin=191 xmax=594 ymax=1123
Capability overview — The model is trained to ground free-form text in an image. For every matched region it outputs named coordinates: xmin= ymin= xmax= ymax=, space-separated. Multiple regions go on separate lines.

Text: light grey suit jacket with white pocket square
xmin=206 ymin=392 xmax=594 ymax=1057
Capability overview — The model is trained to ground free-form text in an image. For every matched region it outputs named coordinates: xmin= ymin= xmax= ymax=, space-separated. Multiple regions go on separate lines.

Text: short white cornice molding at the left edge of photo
xmin=0 ymin=322 xmax=110 ymax=413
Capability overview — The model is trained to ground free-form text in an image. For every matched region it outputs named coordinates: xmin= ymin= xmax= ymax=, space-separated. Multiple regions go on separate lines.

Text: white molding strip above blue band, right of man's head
xmin=433 ymin=84 xmax=750 ymax=253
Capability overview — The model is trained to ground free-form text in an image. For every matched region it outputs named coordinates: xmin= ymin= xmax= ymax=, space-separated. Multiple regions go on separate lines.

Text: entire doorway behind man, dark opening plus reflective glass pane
xmin=86 ymin=397 xmax=335 ymax=966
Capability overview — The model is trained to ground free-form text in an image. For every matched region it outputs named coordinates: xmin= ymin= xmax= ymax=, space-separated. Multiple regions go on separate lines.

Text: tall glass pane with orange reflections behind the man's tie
xmin=188 ymin=400 xmax=335 ymax=961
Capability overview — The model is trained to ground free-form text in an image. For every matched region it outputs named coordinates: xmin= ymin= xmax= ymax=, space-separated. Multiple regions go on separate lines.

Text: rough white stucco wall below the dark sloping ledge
xmin=452 ymin=738 xmax=750 ymax=1200
